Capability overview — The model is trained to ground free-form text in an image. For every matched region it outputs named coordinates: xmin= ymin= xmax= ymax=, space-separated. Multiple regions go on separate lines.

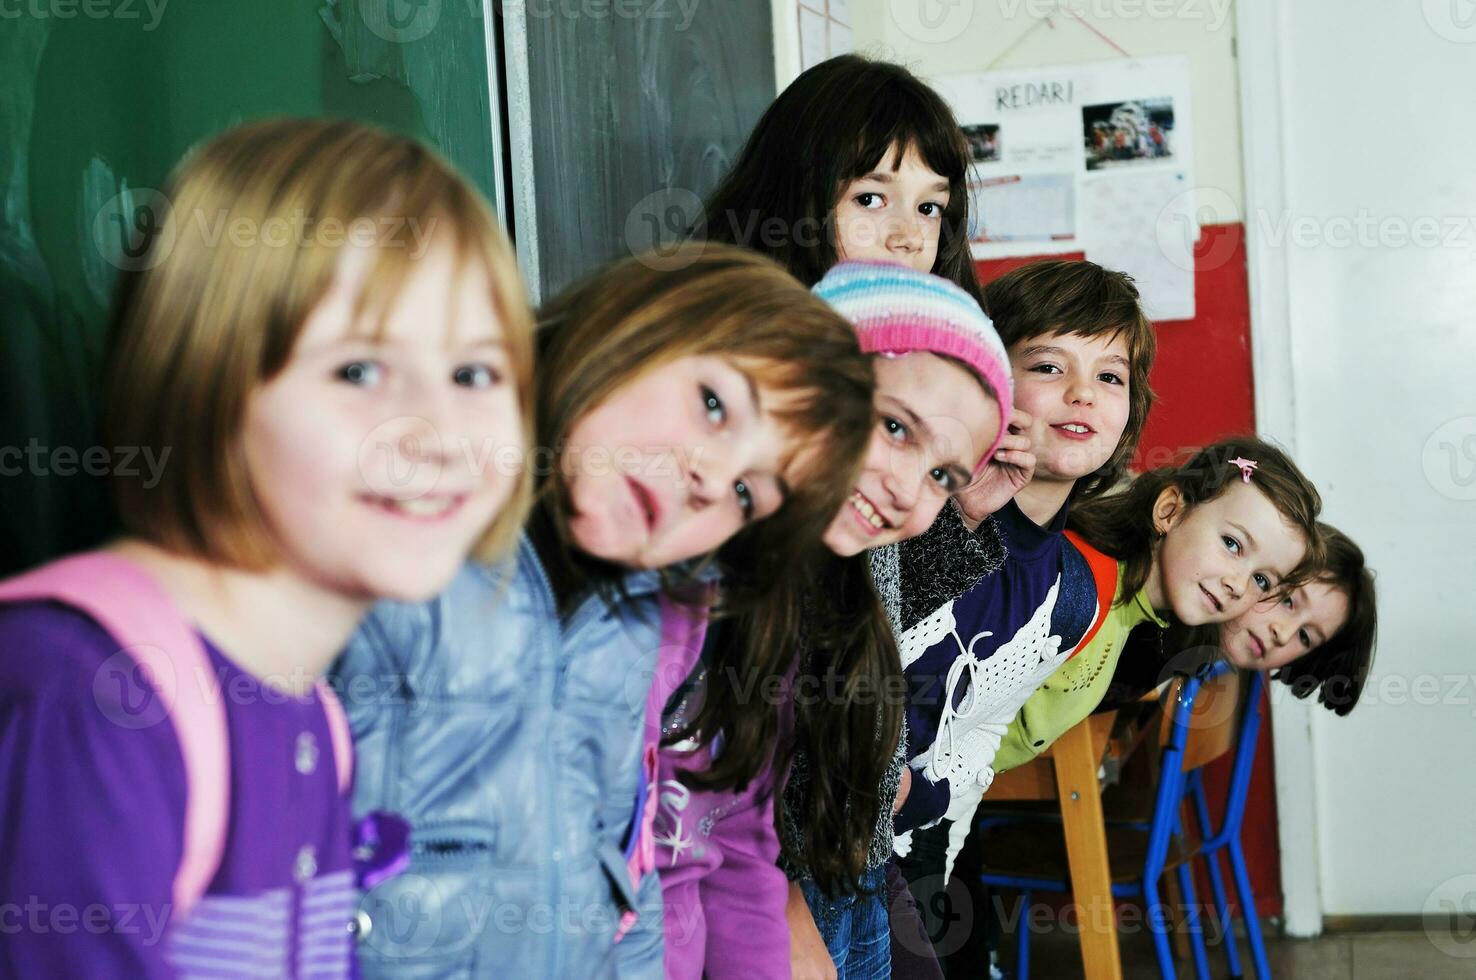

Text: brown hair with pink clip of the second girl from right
xmin=1067 ymin=435 xmax=1325 ymax=602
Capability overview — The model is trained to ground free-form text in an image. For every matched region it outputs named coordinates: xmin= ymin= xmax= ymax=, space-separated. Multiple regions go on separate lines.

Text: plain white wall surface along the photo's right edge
xmin=1244 ymin=0 xmax=1476 ymax=915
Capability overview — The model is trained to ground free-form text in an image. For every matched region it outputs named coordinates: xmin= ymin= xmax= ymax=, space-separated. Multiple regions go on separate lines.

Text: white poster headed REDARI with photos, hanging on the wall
xmin=936 ymin=56 xmax=1197 ymax=320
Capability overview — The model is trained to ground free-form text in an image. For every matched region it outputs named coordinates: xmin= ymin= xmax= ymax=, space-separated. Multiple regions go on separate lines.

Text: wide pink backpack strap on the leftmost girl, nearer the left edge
xmin=0 ymin=552 xmax=227 ymax=915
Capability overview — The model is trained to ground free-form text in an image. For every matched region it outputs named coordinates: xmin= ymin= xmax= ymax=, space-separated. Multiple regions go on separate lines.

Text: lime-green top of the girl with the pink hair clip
xmin=995 ymin=557 xmax=1168 ymax=772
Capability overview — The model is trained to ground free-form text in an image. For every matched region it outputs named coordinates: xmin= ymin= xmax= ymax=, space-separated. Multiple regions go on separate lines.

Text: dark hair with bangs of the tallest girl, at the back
xmin=695 ymin=55 xmax=979 ymax=298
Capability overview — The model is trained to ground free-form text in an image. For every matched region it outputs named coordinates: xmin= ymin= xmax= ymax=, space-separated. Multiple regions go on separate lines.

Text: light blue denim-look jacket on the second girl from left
xmin=335 ymin=536 xmax=661 ymax=980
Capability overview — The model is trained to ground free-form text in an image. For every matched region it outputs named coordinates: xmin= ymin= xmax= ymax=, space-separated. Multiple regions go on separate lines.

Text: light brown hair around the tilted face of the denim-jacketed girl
xmin=536 ymin=242 xmax=874 ymax=593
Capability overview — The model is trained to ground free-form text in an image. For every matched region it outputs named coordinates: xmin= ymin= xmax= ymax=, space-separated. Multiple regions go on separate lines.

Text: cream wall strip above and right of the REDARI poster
xmin=844 ymin=0 xmax=1241 ymax=214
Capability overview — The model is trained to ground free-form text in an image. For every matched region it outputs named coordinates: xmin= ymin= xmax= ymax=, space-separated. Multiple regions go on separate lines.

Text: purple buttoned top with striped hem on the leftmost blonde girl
xmin=0 ymin=602 xmax=357 ymax=980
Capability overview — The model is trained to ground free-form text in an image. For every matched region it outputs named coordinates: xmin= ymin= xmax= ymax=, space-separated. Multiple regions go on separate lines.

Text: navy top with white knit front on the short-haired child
xmin=896 ymin=500 xmax=1106 ymax=838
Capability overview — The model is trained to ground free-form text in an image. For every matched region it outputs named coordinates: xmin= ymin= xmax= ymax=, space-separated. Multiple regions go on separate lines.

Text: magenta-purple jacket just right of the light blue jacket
xmin=634 ymin=617 xmax=790 ymax=980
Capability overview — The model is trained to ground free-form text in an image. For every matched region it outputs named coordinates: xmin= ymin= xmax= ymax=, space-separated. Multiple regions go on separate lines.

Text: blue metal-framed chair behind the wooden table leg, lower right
xmin=979 ymin=663 xmax=1271 ymax=980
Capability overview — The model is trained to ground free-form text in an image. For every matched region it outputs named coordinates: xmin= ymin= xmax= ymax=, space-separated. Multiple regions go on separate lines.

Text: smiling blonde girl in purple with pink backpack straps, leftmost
xmin=0 ymin=120 xmax=533 ymax=980
